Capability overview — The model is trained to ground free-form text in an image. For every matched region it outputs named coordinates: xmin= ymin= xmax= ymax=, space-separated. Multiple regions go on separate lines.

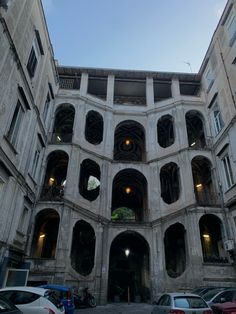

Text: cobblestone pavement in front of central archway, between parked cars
xmin=75 ymin=303 xmax=153 ymax=314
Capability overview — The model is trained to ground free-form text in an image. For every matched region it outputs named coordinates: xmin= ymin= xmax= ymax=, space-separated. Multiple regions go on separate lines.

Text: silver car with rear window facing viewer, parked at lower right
xmin=151 ymin=292 xmax=212 ymax=314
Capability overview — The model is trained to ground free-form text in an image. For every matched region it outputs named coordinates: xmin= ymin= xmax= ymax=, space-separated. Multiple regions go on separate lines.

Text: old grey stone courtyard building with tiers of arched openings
xmin=0 ymin=0 xmax=236 ymax=303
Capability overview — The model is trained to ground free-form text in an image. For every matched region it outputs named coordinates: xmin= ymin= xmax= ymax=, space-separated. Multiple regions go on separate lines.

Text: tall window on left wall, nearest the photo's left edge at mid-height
xmin=7 ymin=100 xmax=24 ymax=146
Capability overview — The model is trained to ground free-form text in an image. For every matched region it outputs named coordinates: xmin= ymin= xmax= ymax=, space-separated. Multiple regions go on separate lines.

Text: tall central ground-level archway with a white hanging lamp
xmin=108 ymin=231 xmax=150 ymax=302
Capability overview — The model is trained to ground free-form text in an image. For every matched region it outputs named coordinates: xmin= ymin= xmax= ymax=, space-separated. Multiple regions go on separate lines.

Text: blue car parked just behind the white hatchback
xmin=40 ymin=284 xmax=75 ymax=314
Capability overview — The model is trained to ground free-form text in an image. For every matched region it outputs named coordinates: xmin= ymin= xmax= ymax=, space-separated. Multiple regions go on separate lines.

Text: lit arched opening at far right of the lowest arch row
xmin=199 ymin=214 xmax=228 ymax=263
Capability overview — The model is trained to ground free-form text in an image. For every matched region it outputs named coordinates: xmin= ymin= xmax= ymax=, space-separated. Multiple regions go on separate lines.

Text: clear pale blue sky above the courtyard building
xmin=42 ymin=0 xmax=227 ymax=73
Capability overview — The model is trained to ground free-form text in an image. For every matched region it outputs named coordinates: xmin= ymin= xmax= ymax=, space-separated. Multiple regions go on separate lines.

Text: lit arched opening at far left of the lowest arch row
xmin=31 ymin=209 xmax=60 ymax=258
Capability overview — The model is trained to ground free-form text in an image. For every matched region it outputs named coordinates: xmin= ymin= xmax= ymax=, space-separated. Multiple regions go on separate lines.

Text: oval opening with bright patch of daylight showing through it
xmin=79 ymin=159 xmax=101 ymax=201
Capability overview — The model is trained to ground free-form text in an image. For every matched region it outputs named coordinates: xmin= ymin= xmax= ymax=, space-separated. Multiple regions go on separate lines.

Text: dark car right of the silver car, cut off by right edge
xmin=202 ymin=288 xmax=236 ymax=306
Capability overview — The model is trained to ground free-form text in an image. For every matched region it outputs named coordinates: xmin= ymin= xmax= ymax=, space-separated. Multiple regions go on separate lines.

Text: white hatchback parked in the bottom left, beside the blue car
xmin=0 ymin=286 xmax=65 ymax=314
